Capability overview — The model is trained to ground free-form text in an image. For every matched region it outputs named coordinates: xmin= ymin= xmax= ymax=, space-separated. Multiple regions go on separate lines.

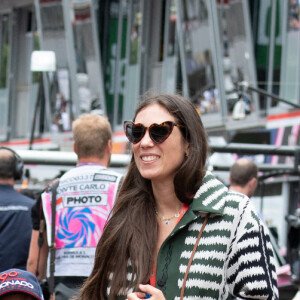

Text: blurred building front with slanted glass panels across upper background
xmin=0 ymin=0 xmax=300 ymax=144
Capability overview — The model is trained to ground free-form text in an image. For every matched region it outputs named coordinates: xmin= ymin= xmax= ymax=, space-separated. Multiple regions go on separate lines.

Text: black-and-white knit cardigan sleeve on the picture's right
xmin=224 ymin=199 xmax=278 ymax=300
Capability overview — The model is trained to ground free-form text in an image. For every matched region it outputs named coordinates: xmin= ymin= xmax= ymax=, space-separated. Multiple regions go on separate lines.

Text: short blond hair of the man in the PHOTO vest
xmin=72 ymin=114 xmax=112 ymax=158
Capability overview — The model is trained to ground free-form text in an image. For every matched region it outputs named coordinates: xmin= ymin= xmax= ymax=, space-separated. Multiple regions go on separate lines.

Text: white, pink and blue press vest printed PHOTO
xmin=42 ymin=164 xmax=122 ymax=276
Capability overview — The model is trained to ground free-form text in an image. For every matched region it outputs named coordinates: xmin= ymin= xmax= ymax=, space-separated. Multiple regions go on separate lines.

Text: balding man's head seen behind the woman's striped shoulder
xmin=229 ymin=158 xmax=258 ymax=198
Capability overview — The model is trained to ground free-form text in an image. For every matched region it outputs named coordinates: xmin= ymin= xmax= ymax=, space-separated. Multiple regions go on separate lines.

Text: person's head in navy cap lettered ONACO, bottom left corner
xmin=0 ymin=269 xmax=44 ymax=300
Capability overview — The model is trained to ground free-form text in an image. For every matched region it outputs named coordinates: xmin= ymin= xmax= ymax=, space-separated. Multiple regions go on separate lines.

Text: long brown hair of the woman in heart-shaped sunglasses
xmin=80 ymin=94 xmax=208 ymax=300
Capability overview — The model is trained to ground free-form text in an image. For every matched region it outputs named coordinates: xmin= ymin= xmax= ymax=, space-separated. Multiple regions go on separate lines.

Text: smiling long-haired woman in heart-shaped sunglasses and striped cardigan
xmin=81 ymin=95 xmax=278 ymax=300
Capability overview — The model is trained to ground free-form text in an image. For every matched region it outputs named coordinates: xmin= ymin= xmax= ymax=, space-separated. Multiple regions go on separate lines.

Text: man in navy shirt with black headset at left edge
xmin=0 ymin=147 xmax=34 ymax=272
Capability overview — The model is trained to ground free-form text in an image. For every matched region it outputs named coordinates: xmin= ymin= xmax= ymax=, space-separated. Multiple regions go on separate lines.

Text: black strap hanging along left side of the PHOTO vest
xmin=49 ymin=179 xmax=59 ymax=294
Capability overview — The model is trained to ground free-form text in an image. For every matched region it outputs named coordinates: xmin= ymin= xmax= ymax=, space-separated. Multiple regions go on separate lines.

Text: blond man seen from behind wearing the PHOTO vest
xmin=27 ymin=114 xmax=122 ymax=300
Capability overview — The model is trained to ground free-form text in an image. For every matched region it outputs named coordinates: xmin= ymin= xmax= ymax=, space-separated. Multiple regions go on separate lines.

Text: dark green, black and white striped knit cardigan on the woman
xmin=116 ymin=172 xmax=278 ymax=300
